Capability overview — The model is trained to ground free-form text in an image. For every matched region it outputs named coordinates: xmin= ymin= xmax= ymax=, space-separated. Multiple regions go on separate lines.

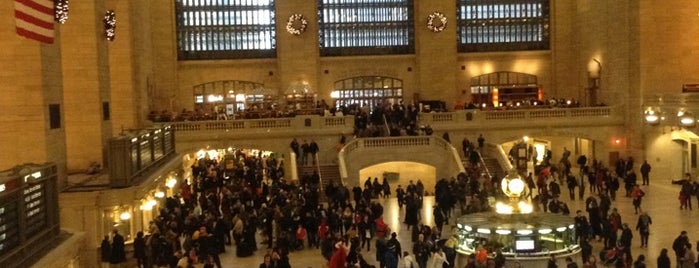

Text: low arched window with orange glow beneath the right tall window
xmin=471 ymin=72 xmax=541 ymax=106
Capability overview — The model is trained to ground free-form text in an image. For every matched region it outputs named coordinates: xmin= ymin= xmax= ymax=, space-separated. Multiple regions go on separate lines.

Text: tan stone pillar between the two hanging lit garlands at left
xmin=60 ymin=1 xmax=113 ymax=173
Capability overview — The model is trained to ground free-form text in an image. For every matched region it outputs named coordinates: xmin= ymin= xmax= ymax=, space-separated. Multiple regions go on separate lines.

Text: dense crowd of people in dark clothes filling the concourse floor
xmin=102 ymin=132 xmax=696 ymax=268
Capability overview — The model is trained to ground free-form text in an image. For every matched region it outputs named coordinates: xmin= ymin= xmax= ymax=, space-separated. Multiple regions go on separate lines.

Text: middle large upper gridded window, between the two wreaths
xmin=318 ymin=0 xmax=415 ymax=56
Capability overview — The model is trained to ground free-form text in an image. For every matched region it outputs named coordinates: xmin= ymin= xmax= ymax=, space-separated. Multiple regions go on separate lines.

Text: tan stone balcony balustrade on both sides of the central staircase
xmin=171 ymin=106 xmax=624 ymax=148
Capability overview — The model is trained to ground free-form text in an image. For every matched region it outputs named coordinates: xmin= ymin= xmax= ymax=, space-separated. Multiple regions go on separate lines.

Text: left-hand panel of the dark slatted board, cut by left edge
xmin=0 ymin=198 xmax=19 ymax=256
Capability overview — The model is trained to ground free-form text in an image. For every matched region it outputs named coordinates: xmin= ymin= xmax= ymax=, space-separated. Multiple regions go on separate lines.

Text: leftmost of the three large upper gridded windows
xmin=175 ymin=0 xmax=276 ymax=60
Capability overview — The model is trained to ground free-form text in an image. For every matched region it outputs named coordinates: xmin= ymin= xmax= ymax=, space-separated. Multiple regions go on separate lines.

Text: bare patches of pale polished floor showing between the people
xmin=215 ymin=181 xmax=699 ymax=268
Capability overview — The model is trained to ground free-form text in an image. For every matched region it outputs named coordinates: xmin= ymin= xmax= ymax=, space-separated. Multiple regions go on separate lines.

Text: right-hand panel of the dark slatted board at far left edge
xmin=23 ymin=183 xmax=46 ymax=234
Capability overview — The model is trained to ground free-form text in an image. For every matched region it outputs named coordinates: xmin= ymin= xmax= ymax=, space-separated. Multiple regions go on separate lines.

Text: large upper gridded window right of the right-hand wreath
xmin=456 ymin=0 xmax=551 ymax=52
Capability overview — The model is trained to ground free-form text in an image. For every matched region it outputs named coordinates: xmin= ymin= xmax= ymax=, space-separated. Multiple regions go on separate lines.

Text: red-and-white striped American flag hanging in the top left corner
xmin=15 ymin=0 xmax=54 ymax=44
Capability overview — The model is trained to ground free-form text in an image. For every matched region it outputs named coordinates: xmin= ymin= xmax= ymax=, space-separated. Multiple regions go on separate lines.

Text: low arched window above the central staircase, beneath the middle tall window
xmin=332 ymin=76 xmax=403 ymax=108
